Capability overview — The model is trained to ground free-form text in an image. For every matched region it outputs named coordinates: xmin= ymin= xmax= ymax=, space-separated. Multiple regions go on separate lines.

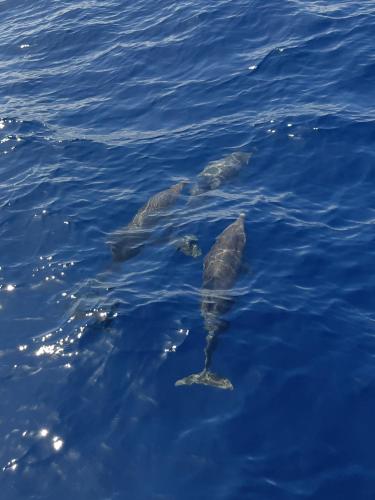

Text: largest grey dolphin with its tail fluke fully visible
xmin=175 ymin=214 xmax=246 ymax=389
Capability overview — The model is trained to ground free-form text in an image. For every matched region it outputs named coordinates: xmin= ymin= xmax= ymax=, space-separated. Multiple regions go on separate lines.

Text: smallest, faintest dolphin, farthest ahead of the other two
xmin=191 ymin=151 xmax=252 ymax=196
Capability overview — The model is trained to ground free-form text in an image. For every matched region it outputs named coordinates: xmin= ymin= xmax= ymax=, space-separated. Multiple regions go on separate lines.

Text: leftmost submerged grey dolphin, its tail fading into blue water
xmin=109 ymin=181 xmax=186 ymax=262
